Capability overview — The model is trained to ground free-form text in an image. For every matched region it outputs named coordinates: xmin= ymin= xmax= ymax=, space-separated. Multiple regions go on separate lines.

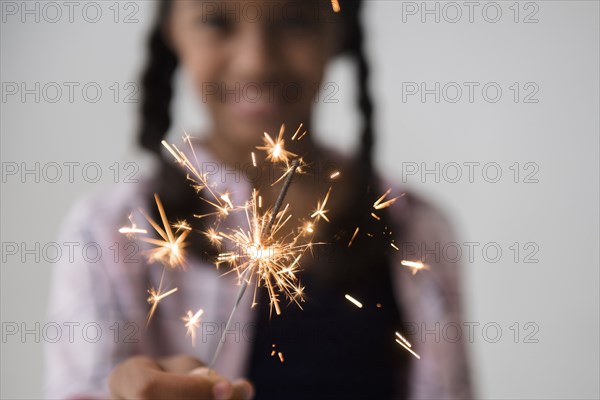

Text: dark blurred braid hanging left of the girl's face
xmin=139 ymin=0 xmax=178 ymax=153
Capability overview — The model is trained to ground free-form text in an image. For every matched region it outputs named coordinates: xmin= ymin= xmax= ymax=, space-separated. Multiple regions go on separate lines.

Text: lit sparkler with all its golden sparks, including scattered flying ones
xmin=119 ymin=119 xmax=426 ymax=369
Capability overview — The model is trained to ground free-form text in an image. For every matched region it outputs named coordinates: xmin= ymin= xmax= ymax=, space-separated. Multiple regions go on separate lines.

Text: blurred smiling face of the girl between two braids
xmin=167 ymin=0 xmax=339 ymax=148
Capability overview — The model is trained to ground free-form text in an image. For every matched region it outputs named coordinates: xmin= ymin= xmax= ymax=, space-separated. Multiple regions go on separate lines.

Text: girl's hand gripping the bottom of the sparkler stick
xmin=108 ymin=356 xmax=254 ymax=400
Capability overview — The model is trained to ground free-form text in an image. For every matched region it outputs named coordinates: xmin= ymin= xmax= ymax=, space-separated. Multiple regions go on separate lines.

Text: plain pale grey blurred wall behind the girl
xmin=0 ymin=0 xmax=600 ymax=399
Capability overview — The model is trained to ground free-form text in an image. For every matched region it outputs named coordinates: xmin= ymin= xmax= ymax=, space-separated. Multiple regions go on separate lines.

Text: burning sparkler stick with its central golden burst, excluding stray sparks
xmin=155 ymin=124 xmax=324 ymax=354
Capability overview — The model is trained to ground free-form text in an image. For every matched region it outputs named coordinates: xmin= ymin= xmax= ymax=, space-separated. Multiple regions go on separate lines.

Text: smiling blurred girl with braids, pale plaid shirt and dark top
xmin=47 ymin=0 xmax=470 ymax=399
